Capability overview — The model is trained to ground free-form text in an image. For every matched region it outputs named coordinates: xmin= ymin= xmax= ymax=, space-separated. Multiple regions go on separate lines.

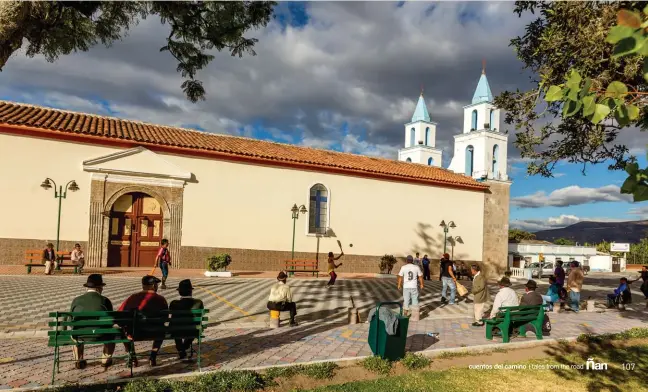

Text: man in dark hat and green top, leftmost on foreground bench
xmin=70 ymin=274 xmax=115 ymax=369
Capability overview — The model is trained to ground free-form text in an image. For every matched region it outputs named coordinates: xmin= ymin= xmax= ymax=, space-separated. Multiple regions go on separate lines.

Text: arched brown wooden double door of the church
xmin=108 ymin=193 xmax=164 ymax=267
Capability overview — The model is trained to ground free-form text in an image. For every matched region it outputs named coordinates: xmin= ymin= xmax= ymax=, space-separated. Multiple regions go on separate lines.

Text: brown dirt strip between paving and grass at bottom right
xmin=266 ymin=339 xmax=648 ymax=392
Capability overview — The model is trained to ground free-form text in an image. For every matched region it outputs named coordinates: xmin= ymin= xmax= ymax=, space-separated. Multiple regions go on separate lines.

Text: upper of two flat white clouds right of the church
xmin=511 ymin=185 xmax=632 ymax=208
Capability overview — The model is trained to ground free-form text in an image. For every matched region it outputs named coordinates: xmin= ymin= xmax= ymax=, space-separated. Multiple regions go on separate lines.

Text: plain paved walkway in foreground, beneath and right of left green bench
xmin=0 ymin=310 xmax=648 ymax=389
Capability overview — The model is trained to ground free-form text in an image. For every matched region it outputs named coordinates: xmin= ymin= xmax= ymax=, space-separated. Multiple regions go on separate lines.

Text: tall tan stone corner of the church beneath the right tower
xmin=480 ymin=180 xmax=511 ymax=278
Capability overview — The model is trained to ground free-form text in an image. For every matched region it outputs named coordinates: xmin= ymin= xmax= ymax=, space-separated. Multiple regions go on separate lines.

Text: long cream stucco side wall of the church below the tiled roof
xmin=0 ymin=134 xmax=484 ymax=260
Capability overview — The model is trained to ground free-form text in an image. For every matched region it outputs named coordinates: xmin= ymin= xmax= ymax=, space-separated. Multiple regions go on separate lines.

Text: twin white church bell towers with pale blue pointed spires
xmin=398 ymin=70 xmax=508 ymax=181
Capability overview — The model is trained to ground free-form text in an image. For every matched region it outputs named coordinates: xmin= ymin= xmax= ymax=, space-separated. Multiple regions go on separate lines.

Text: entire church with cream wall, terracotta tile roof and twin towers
xmin=0 ymin=69 xmax=510 ymax=273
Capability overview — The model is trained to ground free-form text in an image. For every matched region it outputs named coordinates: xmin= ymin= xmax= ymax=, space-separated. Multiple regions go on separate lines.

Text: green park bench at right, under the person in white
xmin=482 ymin=305 xmax=546 ymax=343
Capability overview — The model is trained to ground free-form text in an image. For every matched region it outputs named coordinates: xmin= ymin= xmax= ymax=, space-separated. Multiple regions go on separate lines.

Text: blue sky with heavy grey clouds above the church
xmin=0 ymin=2 xmax=648 ymax=230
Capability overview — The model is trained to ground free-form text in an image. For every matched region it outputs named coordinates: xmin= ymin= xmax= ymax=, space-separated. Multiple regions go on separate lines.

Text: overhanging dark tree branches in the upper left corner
xmin=0 ymin=1 xmax=276 ymax=102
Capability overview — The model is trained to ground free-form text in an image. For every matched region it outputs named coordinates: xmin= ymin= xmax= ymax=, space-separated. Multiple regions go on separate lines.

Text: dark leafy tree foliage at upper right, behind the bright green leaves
xmin=495 ymin=1 xmax=648 ymax=177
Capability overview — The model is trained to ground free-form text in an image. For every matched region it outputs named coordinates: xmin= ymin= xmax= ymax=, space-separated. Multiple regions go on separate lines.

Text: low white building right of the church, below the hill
xmin=508 ymin=240 xmax=596 ymax=270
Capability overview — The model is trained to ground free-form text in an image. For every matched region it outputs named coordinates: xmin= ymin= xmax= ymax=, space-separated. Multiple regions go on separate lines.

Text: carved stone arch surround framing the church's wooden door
xmin=88 ymin=176 xmax=184 ymax=267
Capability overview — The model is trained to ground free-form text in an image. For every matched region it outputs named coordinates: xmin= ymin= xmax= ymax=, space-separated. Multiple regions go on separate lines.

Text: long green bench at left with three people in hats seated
xmin=47 ymin=309 xmax=209 ymax=384
